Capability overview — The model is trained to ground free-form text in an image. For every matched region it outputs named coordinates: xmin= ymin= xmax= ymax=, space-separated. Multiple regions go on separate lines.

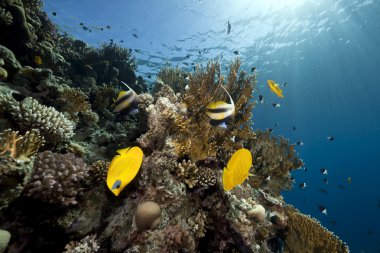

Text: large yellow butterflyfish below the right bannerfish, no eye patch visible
xmin=223 ymin=148 xmax=252 ymax=191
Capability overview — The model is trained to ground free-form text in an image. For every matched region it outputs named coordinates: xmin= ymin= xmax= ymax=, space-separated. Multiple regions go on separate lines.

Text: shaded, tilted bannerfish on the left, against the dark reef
xmin=112 ymin=81 xmax=138 ymax=114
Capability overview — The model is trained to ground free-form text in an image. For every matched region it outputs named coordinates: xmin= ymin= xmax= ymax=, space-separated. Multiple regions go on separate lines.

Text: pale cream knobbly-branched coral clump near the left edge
xmin=2 ymin=97 xmax=75 ymax=143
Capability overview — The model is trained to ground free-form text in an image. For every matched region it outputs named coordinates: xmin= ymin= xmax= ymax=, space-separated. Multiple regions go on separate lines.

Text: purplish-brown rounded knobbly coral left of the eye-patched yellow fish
xmin=25 ymin=151 xmax=88 ymax=206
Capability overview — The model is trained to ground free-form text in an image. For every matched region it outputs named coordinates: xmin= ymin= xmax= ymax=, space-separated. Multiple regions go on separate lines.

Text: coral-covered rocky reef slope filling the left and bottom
xmin=0 ymin=0 xmax=349 ymax=253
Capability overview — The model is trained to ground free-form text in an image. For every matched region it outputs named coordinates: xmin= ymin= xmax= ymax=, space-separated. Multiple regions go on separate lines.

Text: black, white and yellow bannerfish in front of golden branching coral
xmin=206 ymin=85 xmax=235 ymax=128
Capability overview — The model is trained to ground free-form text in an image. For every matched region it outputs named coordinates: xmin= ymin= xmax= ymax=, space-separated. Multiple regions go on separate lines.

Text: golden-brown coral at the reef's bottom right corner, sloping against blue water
xmin=285 ymin=205 xmax=349 ymax=253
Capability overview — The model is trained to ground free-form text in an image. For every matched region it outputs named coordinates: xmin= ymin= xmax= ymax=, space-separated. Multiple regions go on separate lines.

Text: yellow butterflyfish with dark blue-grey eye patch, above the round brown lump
xmin=107 ymin=147 xmax=144 ymax=196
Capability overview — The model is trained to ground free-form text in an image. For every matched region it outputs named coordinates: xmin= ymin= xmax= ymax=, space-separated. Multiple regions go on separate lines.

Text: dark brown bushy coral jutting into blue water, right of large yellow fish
xmin=250 ymin=131 xmax=302 ymax=195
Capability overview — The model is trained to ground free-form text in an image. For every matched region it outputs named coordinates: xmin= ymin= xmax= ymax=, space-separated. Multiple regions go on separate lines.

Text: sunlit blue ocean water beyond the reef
xmin=44 ymin=0 xmax=380 ymax=252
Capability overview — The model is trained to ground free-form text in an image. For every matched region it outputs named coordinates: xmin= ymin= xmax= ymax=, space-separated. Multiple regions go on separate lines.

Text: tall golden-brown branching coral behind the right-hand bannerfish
xmin=176 ymin=60 xmax=255 ymax=161
